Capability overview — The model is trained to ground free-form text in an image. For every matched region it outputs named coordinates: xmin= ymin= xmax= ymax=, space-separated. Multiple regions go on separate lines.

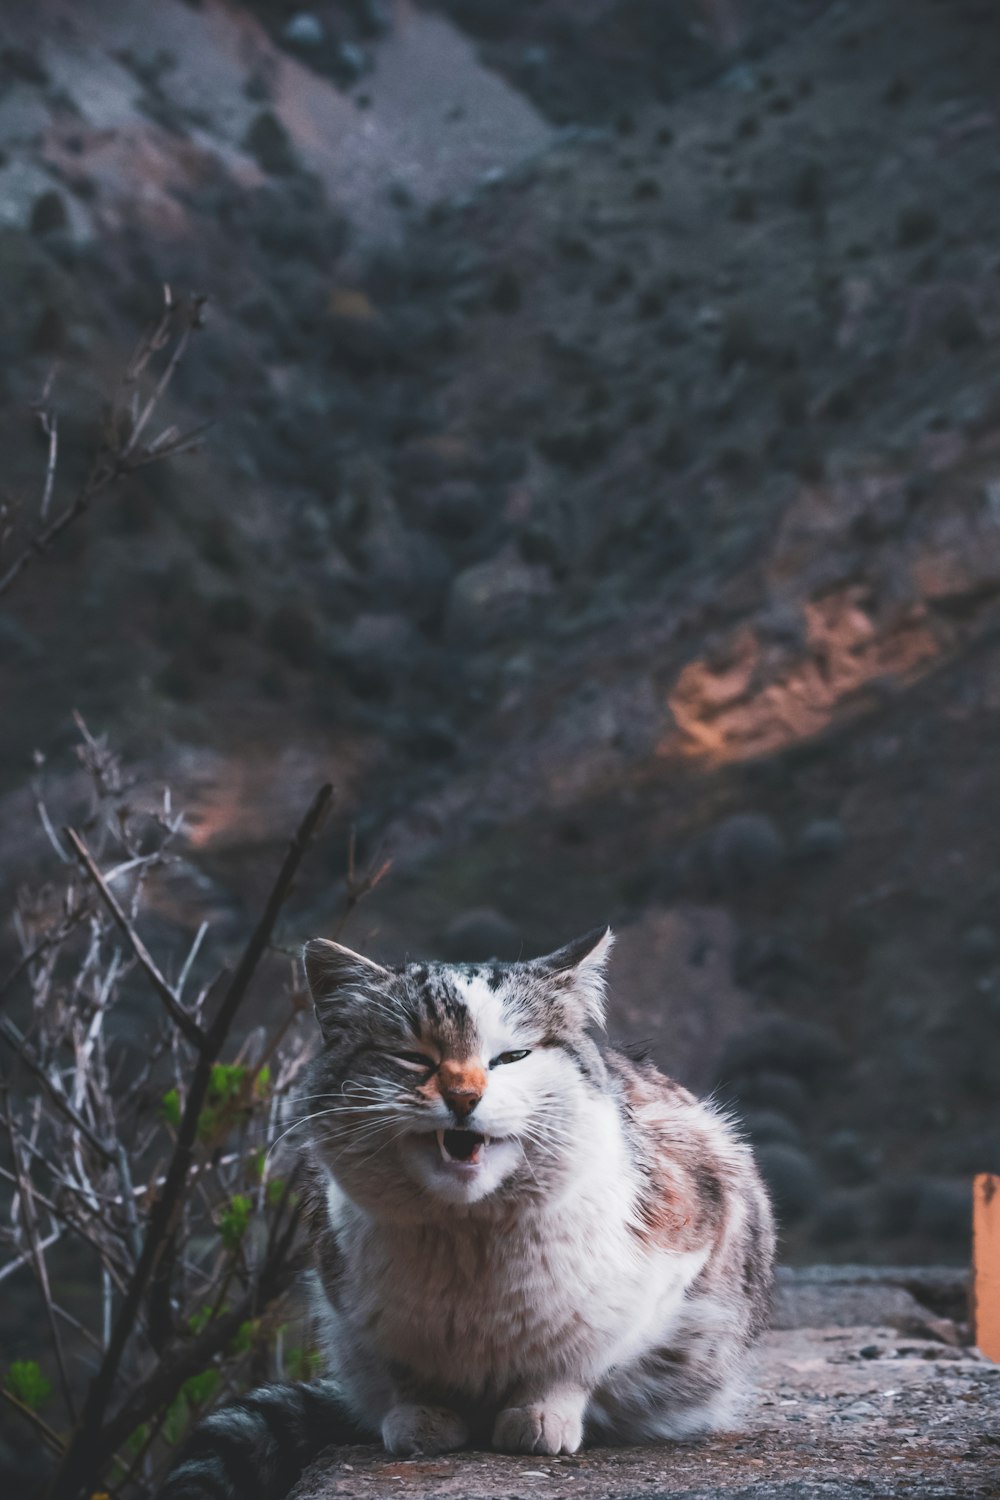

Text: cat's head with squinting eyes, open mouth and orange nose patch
xmin=301 ymin=930 xmax=613 ymax=1211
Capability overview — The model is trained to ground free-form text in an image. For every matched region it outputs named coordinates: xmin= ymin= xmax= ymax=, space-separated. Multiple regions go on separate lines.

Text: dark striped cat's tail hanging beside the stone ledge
xmin=157 ymin=1380 xmax=372 ymax=1500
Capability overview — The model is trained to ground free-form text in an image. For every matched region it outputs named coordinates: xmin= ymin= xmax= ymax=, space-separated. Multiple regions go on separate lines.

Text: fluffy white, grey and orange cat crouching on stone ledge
xmin=162 ymin=930 xmax=775 ymax=1500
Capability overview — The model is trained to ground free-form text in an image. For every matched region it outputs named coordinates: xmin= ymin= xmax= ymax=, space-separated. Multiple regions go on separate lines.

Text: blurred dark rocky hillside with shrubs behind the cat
xmin=0 ymin=0 xmax=1000 ymax=1262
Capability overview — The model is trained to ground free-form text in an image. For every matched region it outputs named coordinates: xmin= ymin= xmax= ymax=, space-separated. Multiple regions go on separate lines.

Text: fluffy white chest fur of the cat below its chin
xmin=325 ymin=1152 xmax=703 ymax=1397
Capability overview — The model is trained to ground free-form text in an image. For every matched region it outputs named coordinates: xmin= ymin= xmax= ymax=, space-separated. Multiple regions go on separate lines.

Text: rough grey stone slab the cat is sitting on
xmin=292 ymin=1332 xmax=1000 ymax=1500
